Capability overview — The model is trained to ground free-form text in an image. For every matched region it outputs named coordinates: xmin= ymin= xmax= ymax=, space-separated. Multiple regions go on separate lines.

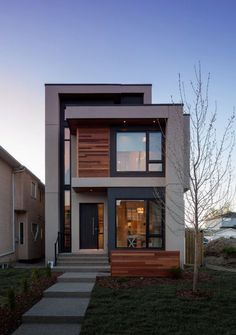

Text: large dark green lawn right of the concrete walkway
xmin=81 ymin=270 xmax=236 ymax=335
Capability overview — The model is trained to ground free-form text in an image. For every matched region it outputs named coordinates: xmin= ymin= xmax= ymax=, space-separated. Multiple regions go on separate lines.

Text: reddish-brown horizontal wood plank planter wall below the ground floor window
xmin=111 ymin=250 xmax=180 ymax=277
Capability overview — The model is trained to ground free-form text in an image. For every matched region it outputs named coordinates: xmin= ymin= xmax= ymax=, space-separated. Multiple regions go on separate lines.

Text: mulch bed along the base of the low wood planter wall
xmin=97 ymin=271 xmax=212 ymax=289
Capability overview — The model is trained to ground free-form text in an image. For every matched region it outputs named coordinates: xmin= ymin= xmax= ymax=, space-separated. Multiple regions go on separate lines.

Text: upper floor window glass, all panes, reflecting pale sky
xmin=115 ymin=130 xmax=164 ymax=173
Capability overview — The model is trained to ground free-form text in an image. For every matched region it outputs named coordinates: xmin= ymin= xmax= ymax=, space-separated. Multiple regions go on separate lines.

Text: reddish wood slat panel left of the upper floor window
xmin=77 ymin=128 xmax=110 ymax=177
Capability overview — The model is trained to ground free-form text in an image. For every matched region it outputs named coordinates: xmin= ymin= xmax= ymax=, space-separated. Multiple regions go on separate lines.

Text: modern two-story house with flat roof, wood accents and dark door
xmin=45 ymin=84 xmax=189 ymax=264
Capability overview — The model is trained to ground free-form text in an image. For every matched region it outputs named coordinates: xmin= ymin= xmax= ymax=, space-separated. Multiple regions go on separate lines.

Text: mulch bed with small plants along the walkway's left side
xmin=0 ymin=273 xmax=60 ymax=335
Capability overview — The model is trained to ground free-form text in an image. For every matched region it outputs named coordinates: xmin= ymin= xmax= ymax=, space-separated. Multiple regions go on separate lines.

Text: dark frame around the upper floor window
xmin=110 ymin=126 xmax=165 ymax=177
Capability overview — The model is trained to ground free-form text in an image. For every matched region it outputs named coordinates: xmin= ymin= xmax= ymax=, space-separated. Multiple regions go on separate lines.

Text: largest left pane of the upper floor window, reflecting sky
xmin=116 ymin=132 xmax=146 ymax=171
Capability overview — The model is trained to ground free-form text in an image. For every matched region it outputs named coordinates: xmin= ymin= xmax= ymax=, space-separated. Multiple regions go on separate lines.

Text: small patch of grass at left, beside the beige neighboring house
xmin=0 ymin=268 xmax=44 ymax=305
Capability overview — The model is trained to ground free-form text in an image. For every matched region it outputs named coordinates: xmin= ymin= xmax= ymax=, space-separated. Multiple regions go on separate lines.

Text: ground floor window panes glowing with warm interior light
xmin=116 ymin=199 xmax=164 ymax=249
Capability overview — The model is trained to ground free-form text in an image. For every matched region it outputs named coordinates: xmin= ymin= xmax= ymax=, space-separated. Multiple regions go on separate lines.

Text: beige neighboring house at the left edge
xmin=0 ymin=146 xmax=45 ymax=264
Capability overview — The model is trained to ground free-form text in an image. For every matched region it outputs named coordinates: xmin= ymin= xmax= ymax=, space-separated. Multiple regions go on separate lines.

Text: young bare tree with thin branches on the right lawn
xmin=157 ymin=64 xmax=235 ymax=291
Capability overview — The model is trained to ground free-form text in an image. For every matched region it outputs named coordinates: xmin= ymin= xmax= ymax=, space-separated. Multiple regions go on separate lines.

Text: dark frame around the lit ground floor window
xmin=115 ymin=197 xmax=166 ymax=250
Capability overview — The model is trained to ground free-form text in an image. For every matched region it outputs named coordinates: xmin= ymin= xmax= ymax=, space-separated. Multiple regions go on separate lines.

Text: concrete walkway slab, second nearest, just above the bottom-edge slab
xmin=22 ymin=298 xmax=89 ymax=324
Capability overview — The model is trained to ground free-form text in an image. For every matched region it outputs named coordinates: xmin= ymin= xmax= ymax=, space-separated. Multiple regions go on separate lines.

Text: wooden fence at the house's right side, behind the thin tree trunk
xmin=185 ymin=229 xmax=204 ymax=265
